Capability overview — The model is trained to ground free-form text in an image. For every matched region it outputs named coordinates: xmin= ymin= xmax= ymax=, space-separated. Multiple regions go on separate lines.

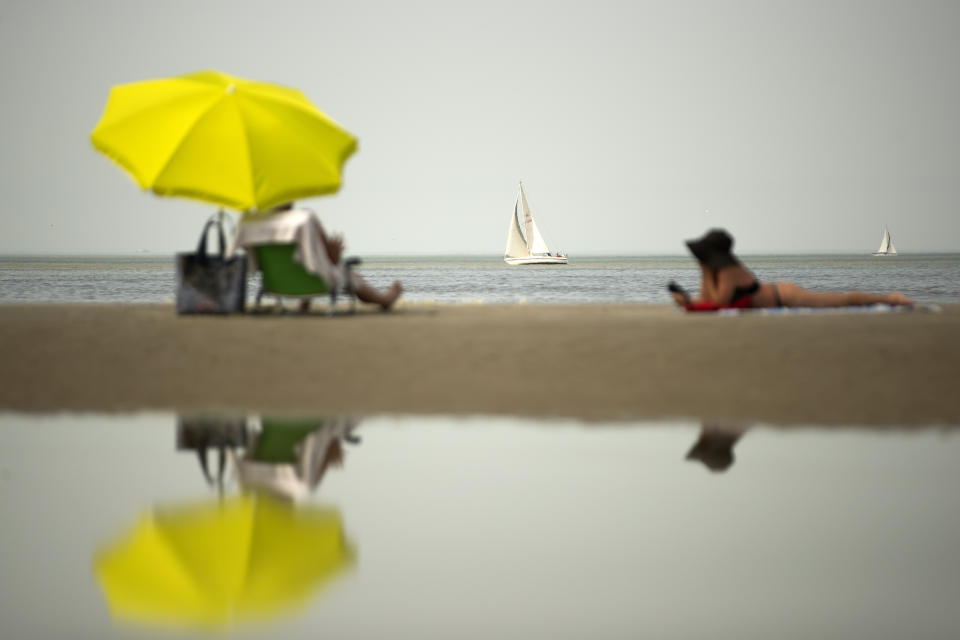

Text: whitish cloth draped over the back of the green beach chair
xmin=233 ymin=208 xmax=358 ymax=288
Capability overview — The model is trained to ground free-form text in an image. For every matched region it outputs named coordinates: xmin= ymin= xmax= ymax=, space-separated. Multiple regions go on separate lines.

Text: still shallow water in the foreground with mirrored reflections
xmin=0 ymin=414 xmax=960 ymax=638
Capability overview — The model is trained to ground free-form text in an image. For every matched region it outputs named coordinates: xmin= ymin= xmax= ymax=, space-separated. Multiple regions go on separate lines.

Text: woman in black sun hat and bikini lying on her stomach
xmin=668 ymin=229 xmax=914 ymax=311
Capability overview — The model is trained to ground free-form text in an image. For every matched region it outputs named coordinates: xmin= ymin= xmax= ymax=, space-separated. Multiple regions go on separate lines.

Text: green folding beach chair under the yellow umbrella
xmin=253 ymin=244 xmax=360 ymax=315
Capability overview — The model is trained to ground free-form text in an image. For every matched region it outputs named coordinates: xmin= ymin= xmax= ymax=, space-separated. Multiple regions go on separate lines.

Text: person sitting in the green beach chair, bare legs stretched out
xmin=235 ymin=202 xmax=403 ymax=310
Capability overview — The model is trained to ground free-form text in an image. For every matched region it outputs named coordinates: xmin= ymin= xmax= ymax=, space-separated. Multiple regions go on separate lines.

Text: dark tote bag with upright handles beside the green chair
xmin=177 ymin=213 xmax=247 ymax=314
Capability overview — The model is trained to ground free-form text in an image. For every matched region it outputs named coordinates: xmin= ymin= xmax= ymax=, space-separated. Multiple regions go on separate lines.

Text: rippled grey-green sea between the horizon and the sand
xmin=0 ymin=253 xmax=960 ymax=304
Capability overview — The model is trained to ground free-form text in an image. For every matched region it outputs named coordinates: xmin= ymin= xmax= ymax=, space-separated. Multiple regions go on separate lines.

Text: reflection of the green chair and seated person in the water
xmin=236 ymin=418 xmax=360 ymax=500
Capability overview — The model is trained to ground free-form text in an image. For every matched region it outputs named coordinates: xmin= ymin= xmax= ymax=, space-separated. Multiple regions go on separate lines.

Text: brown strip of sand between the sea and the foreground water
xmin=0 ymin=305 xmax=960 ymax=425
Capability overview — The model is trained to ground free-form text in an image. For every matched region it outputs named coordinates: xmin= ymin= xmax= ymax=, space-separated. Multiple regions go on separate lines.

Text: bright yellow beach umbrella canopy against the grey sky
xmin=90 ymin=71 xmax=357 ymax=210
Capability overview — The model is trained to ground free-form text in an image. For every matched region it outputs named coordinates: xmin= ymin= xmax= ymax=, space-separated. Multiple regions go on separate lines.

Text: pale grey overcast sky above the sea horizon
xmin=0 ymin=0 xmax=960 ymax=257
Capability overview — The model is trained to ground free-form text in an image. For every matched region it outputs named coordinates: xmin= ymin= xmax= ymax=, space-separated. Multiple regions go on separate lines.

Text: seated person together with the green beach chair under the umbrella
xmin=234 ymin=202 xmax=403 ymax=313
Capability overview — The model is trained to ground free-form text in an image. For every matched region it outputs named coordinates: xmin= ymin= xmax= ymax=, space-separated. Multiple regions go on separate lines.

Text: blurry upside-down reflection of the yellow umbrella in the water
xmin=95 ymin=496 xmax=352 ymax=628
